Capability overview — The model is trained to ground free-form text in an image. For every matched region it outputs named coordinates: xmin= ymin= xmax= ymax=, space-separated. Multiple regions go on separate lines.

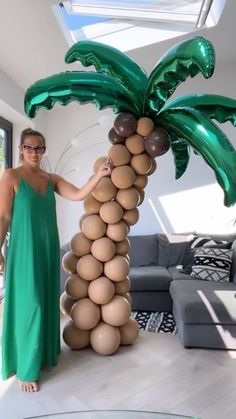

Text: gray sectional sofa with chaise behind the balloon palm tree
xmin=61 ymin=233 xmax=236 ymax=349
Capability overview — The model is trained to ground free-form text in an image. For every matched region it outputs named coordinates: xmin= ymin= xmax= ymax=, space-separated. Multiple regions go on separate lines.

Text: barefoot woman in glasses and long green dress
xmin=0 ymin=129 xmax=112 ymax=392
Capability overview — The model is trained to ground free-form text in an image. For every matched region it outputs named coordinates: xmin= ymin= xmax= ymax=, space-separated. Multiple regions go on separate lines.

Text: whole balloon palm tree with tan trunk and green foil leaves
xmin=25 ymin=36 xmax=236 ymax=354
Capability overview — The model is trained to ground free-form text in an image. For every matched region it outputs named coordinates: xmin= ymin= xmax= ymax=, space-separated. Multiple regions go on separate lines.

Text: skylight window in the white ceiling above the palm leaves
xmin=54 ymin=0 xmax=226 ymax=52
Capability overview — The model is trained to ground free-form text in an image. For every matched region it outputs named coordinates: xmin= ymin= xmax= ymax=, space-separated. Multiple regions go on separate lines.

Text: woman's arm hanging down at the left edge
xmin=0 ymin=169 xmax=15 ymax=272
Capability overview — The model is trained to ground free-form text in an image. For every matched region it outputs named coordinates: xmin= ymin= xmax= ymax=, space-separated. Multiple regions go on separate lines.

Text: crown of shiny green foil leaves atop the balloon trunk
xmin=25 ymin=36 xmax=236 ymax=206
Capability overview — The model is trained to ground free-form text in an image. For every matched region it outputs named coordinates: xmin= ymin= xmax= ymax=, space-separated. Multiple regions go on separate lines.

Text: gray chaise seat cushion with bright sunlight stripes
xmin=170 ymin=280 xmax=236 ymax=324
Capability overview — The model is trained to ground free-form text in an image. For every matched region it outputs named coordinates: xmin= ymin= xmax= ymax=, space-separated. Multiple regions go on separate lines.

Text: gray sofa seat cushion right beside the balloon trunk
xmin=129 ymin=266 xmax=172 ymax=291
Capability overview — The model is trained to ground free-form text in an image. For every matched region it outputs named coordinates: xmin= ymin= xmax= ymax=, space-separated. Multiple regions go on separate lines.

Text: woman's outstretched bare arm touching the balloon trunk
xmin=52 ymin=160 xmax=112 ymax=201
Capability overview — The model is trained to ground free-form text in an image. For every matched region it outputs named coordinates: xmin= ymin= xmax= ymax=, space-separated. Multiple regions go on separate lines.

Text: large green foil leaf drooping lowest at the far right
xmin=155 ymin=107 xmax=236 ymax=206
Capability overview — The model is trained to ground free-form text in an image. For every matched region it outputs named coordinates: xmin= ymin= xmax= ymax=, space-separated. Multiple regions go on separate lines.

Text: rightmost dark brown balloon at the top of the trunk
xmin=144 ymin=127 xmax=170 ymax=157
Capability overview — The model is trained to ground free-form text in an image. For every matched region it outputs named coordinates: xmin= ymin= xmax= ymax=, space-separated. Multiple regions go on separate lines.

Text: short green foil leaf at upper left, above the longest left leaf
xmin=65 ymin=41 xmax=148 ymax=112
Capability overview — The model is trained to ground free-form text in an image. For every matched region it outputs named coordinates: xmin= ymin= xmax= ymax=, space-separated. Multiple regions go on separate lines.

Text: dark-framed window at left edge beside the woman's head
xmin=0 ymin=116 xmax=12 ymax=176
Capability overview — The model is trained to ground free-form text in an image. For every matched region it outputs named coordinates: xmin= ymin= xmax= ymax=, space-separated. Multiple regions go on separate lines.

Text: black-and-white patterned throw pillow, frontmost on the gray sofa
xmin=191 ymin=247 xmax=232 ymax=282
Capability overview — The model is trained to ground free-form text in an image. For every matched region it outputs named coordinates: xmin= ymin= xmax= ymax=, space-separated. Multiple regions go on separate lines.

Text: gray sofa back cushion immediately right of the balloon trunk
xmin=128 ymin=234 xmax=158 ymax=266
